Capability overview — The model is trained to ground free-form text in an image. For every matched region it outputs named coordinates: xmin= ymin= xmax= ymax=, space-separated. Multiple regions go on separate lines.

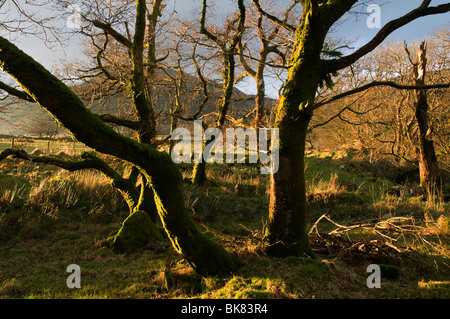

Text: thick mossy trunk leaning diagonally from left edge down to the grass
xmin=0 ymin=37 xmax=237 ymax=275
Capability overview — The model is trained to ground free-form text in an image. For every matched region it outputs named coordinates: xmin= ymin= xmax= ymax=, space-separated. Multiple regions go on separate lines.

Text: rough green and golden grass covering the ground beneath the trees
xmin=0 ymin=153 xmax=450 ymax=299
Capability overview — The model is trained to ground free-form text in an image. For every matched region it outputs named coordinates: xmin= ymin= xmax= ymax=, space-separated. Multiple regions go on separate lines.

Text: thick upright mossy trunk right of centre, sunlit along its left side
xmin=265 ymin=1 xmax=355 ymax=257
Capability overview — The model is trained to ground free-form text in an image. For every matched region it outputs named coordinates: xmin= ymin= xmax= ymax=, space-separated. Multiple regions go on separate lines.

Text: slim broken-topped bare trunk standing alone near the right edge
xmin=414 ymin=42 xmax=439 ymax=190
